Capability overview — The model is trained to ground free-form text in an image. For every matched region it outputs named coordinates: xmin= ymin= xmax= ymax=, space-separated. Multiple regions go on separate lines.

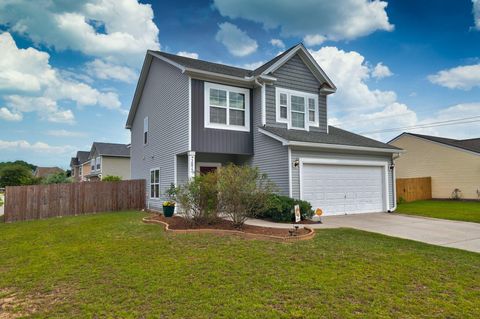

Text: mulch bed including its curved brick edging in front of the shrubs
xmin=144 ymin=214 xmax=314 ymax=241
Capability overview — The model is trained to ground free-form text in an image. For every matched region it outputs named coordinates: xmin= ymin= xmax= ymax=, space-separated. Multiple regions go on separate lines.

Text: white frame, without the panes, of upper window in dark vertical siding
xmin=204 ymin=82 xmax=250 ymax=132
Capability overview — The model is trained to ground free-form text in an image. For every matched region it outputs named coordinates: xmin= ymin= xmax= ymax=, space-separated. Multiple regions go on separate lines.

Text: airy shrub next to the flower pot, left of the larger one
xmin=175 ymin=172 xmax=218 ymax=223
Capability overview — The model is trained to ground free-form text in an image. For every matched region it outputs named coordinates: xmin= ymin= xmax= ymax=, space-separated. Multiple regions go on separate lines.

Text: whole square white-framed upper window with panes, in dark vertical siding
xmin=205 ymin=82 xmax=250 ymax=132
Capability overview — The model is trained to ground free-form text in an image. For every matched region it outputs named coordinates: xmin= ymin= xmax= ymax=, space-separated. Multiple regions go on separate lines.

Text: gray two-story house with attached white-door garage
xmin=126 ymin=44 xmax=401 ymax=215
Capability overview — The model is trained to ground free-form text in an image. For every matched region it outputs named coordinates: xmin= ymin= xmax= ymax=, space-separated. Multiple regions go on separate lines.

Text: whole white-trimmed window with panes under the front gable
xmin=276 ymin=88 xmax=319 ymax=130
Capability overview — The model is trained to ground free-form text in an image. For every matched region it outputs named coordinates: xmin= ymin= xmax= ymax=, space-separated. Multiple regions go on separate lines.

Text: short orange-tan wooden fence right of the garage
xmin=397 ymin=177 xmax=432 ymax=202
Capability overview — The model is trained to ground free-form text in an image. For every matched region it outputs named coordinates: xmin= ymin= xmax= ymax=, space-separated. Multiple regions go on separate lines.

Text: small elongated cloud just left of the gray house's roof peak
xmin=86 ymin=59 xmax=137 ymax=83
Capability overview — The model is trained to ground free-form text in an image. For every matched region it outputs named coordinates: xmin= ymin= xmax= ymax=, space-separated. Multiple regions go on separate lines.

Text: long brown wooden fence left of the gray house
xmin=4 ymin=179 xmax=145 ymax=222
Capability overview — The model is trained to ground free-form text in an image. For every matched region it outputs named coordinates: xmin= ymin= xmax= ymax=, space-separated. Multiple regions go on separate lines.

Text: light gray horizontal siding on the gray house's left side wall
xmin=131 ymin=59 xmax=189 ymax=209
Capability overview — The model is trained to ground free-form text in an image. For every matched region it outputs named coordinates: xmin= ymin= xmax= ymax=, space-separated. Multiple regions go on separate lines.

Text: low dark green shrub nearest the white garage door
xmin=253 ymin=194 xmax=313 ymax=222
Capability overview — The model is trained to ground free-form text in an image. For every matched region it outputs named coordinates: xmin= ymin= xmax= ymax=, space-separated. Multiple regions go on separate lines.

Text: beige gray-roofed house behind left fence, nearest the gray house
xmin=84 ymin=142 xmax=130 ymax=181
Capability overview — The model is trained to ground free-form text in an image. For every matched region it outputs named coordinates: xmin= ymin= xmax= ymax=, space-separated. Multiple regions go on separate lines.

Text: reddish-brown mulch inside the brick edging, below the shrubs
xmin=149 ymin=214 xmax=311 ymax=237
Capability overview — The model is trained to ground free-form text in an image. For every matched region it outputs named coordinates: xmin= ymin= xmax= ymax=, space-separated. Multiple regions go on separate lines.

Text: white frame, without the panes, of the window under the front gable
xmin=275 ymin=87 xmax=319 ymax=131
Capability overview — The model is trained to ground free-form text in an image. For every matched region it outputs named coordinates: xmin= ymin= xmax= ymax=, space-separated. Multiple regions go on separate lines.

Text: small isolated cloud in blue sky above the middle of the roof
xmin=215 ymin=22 xmax=258 ymax=57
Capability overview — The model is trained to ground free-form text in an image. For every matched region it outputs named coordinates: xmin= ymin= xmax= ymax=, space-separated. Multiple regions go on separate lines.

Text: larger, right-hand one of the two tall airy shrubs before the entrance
xmin=216 ymin=164 xmax=274 ymax=227
